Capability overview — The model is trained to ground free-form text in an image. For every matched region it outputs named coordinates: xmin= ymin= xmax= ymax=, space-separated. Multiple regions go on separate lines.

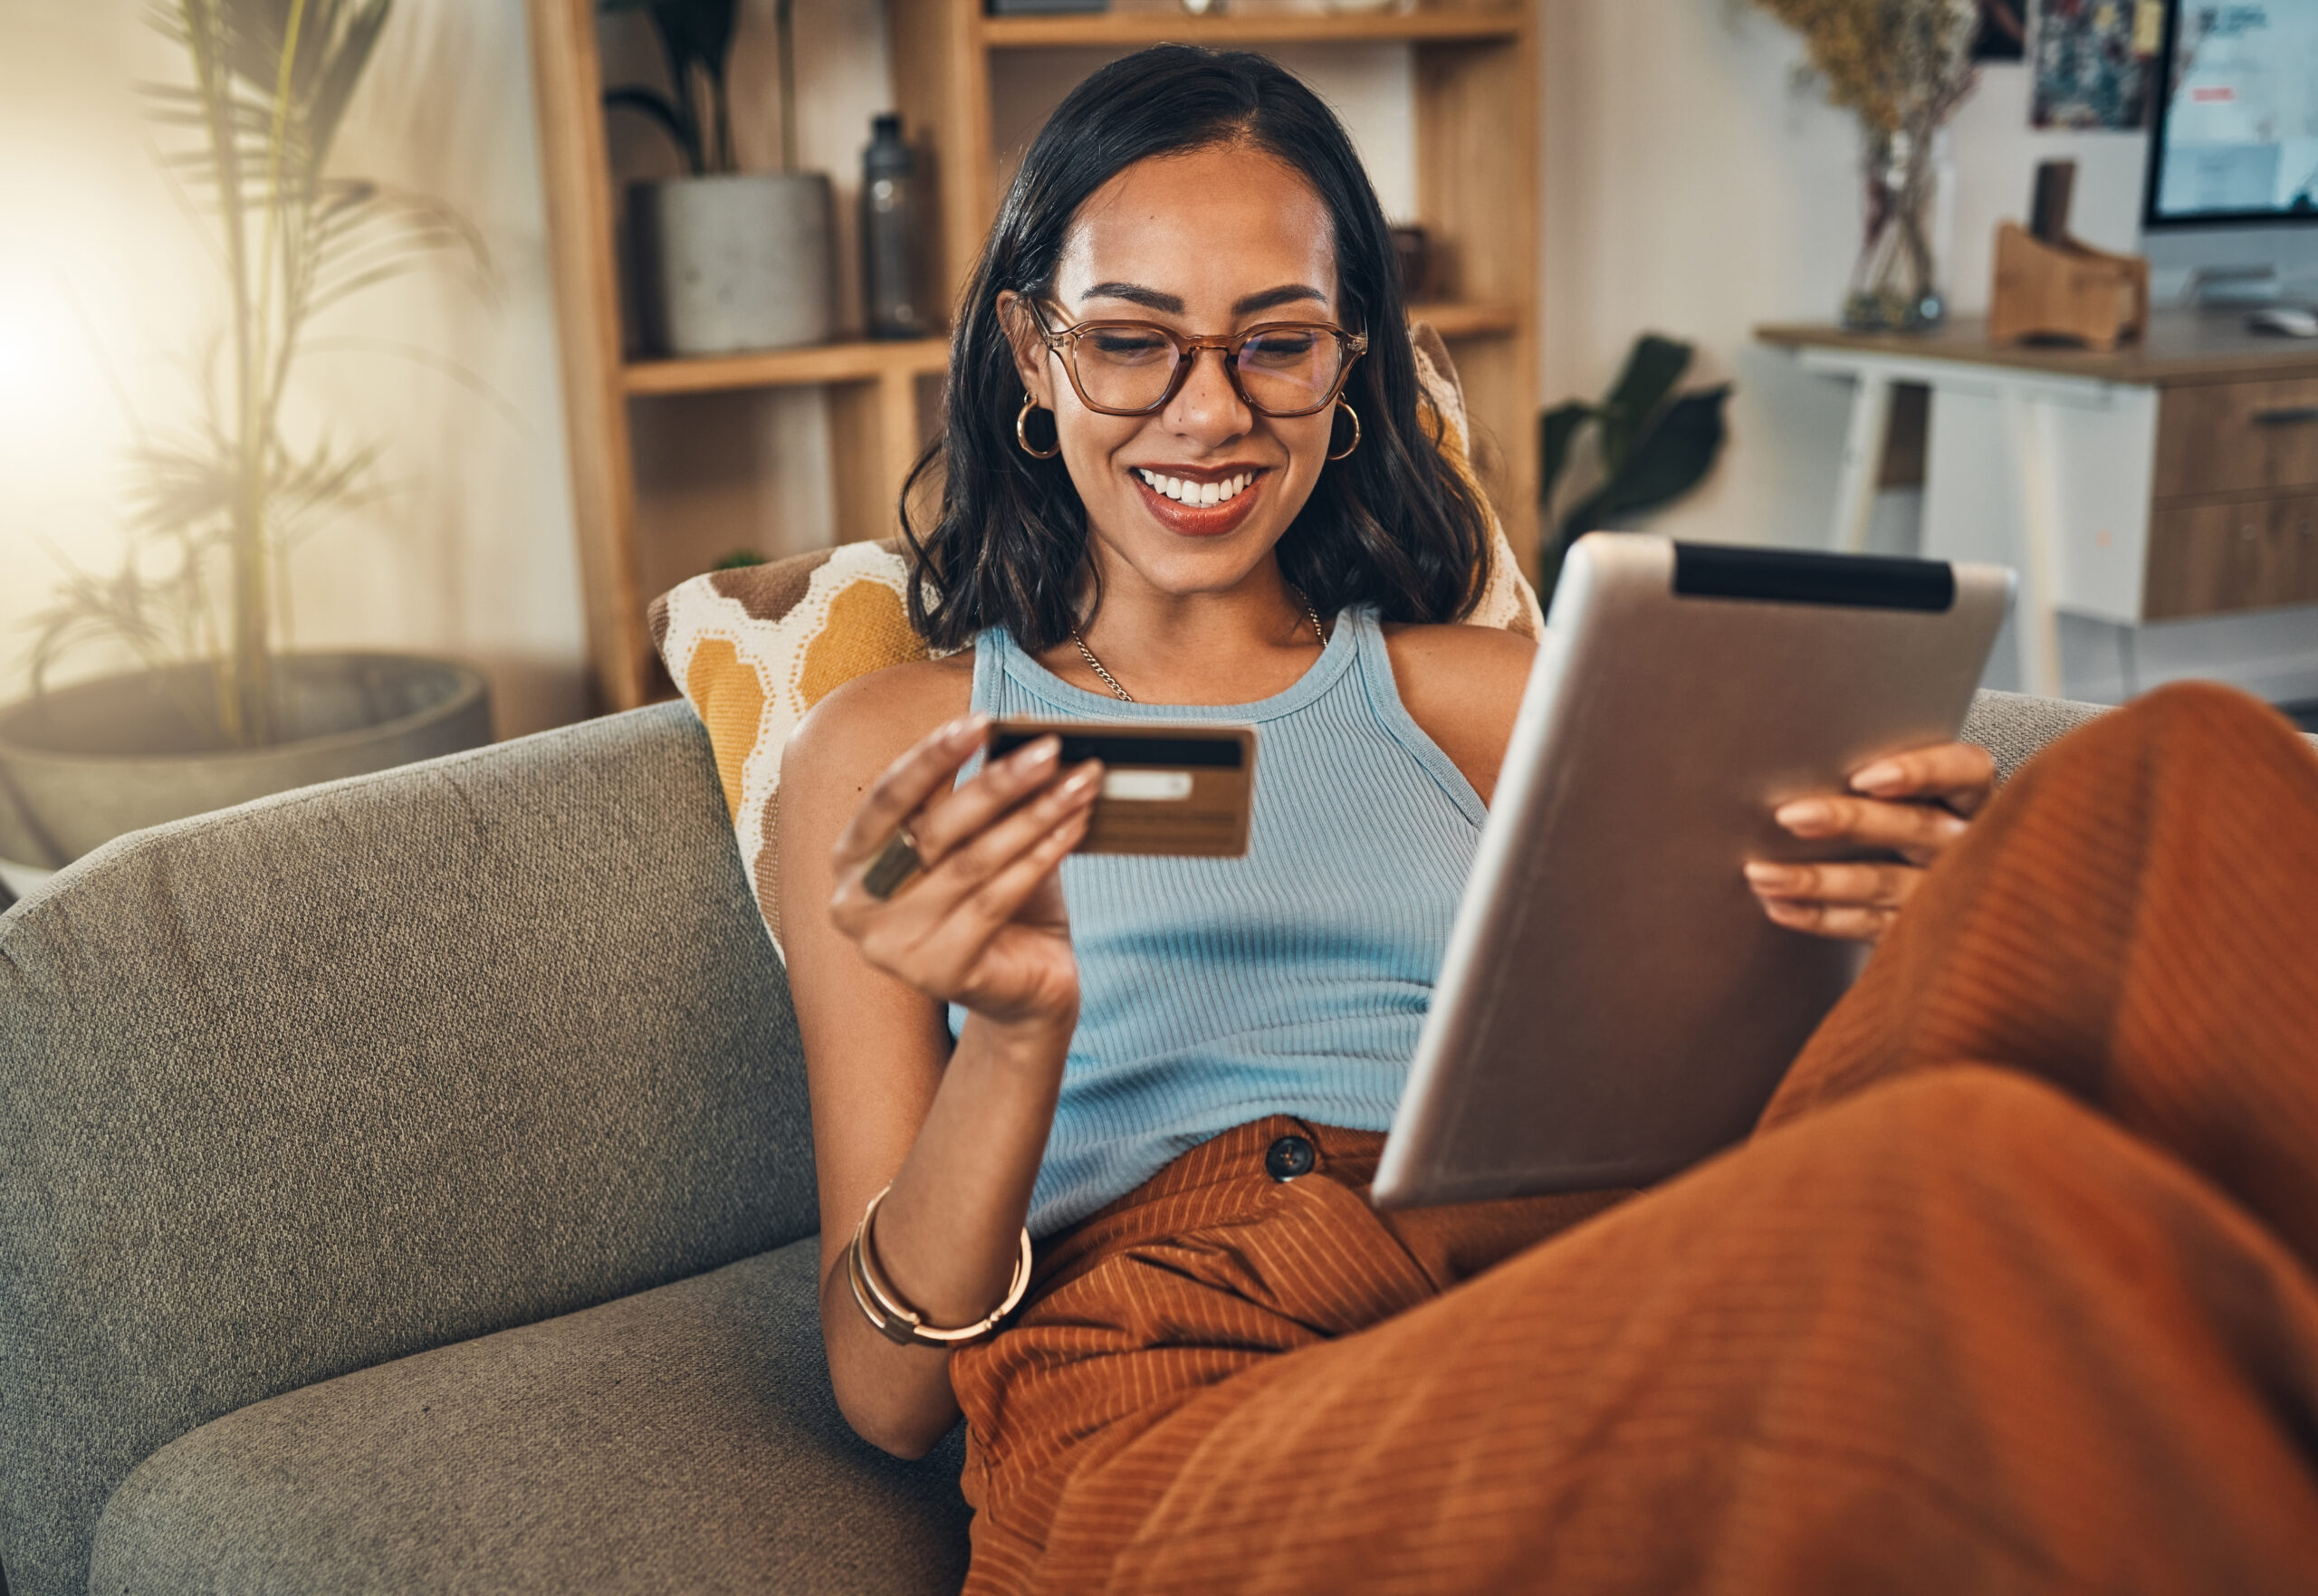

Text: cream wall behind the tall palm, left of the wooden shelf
xmin=0 ymin=0 xmax=589 ymax=734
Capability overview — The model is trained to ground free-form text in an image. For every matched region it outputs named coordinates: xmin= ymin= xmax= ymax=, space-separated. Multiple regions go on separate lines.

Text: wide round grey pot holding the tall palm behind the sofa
xmin=0 ymin=654 xmax=492 ymax=869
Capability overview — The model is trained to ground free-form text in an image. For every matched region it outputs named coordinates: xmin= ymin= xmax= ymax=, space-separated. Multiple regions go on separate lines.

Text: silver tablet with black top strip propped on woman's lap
xmin=1375 ymin=533 xmax=2012 ymax=1207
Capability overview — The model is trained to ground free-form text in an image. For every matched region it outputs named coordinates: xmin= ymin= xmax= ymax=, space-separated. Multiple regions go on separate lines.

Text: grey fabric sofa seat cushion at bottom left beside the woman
xmin=91 ymin=1239 xmax=967 ymax=1596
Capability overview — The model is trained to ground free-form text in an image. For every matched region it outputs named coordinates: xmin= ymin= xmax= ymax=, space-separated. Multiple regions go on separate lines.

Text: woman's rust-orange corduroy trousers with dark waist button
xmin=953 ymin=688 xmax=2318 ymax=1596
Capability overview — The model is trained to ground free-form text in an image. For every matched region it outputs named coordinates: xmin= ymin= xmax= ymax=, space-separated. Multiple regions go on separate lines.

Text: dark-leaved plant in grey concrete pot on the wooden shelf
xmin=598 ymin=0 xmax=837 ymax=354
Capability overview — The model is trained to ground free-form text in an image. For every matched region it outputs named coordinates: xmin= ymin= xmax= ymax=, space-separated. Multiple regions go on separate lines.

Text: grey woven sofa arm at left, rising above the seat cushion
xmin=0 ymin=704 xmax=816 ymax=1593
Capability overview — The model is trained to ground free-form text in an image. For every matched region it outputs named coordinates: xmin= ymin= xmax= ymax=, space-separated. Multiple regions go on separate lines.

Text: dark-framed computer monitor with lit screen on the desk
xmin=2141 ymin=0 xmax=2318 ymax=229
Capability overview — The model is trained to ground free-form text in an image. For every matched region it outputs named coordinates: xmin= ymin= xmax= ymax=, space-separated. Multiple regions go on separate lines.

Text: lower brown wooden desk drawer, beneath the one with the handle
xmin=2141 ymin=496 xmax=2318 ymax=621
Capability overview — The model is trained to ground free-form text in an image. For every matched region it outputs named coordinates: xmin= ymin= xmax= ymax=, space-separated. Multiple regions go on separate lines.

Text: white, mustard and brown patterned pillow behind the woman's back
xmin=651 ymin=322 xmax=1544 ymax=957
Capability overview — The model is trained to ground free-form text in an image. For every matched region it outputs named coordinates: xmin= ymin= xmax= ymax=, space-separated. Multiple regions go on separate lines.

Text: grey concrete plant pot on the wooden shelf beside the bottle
xmin=628 ymin=171 xmax=837 ymax=354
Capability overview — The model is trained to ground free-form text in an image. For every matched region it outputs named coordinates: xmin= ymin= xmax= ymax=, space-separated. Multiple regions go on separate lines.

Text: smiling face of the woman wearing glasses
xmin=999 ymin=148 xmax=1363 ymax=593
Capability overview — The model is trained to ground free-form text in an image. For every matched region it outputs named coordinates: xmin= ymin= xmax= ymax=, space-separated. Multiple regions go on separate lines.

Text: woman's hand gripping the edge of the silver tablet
xmin=1746 ymin=743 xmax=1996 ymax=942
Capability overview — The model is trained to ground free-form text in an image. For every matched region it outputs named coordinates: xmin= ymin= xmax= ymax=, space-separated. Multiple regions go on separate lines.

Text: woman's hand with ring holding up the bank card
xmin=829 ymin=716 xmax=1104 ymax=1027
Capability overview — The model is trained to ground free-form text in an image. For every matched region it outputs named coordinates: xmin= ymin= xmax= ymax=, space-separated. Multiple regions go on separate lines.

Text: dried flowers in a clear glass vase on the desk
xmin=1755 ymin=0 xmax=1984 ymax=331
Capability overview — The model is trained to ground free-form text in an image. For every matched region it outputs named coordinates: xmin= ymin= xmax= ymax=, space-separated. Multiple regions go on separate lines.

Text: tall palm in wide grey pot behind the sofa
xmin=0 ymin=0 xmax=492 ymax=866
